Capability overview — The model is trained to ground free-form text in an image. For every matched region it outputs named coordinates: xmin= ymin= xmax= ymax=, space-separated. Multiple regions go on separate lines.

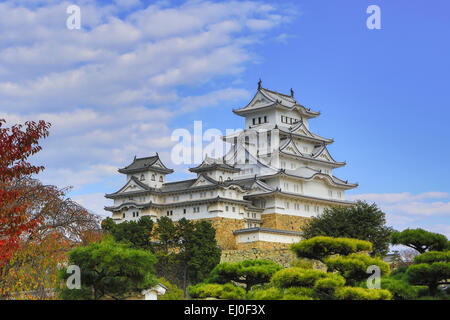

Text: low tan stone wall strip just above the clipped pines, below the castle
xmin=220 ymin=248 xmax=296 ymax=267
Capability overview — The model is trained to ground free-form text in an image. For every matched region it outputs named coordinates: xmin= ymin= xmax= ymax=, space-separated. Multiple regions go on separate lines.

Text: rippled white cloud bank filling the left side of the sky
xmin=0 ymin=0 xmax=292 ymax=218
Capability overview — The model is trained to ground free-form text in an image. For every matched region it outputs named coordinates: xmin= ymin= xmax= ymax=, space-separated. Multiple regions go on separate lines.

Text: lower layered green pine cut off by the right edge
xmin=406 ymin=251 xmax=450 ymax=296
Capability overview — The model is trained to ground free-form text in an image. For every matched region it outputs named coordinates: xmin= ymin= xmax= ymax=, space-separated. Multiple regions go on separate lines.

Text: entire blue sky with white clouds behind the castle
xmin=0 ymin=0 xmax=450 ymax=236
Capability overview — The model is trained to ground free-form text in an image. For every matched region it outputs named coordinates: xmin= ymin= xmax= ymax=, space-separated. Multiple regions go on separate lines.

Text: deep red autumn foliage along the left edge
xmin=0 ymin=119 xmax=50 ymax=266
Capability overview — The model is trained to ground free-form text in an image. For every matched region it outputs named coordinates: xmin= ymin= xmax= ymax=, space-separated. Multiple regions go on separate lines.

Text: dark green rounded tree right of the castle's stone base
xmin=302 ymin=201 xmax=392 ymax=255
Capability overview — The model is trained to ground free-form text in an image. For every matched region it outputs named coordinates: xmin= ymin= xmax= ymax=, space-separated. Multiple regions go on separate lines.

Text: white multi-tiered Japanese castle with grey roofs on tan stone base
xmin=105 ymin=81 xmax=357 ymax=250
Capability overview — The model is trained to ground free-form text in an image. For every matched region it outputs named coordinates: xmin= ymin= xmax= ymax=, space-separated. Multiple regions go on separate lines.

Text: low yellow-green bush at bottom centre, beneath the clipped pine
xmin=187 ymin=283 xmax=245 ymax=300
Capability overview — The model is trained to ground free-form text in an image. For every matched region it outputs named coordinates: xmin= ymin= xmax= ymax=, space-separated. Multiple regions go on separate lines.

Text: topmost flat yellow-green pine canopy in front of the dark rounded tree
xmin=291 ymin=236 xmax=372 ymax=261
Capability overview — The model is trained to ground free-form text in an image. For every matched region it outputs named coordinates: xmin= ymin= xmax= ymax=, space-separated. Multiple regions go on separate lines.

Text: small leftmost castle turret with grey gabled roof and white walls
xmin=119 ymin=153 xmax=173 ymax=188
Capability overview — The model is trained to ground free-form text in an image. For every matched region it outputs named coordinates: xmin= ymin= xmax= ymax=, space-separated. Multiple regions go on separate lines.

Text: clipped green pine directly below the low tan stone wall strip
xmin=208 ymin=260 xmax=281 ymax=291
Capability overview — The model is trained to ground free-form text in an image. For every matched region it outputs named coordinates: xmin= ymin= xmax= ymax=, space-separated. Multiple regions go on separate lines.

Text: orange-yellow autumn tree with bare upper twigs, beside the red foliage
xmin=0 ymin=178 xmax=102 ymax=300
